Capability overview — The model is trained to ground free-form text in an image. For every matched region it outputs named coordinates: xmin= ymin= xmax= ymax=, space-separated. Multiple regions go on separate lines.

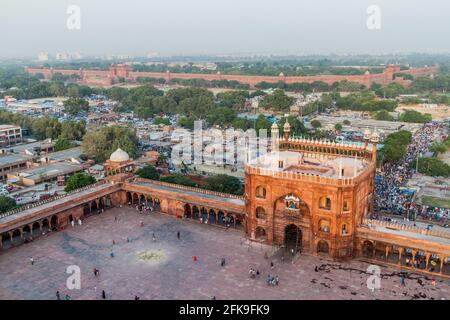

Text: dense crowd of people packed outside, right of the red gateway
xmin=375 ymin=122 xmax=450 ymax=220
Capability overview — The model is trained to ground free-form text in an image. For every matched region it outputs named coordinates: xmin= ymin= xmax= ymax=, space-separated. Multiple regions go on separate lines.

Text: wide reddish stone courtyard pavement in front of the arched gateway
xmin=0 ymin=206 xmax=450 ymax=300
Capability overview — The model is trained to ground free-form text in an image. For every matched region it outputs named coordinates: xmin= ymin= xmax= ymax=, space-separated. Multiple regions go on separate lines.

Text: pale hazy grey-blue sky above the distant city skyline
xmin=0 ymin=0 xmax=450 ymax=57
